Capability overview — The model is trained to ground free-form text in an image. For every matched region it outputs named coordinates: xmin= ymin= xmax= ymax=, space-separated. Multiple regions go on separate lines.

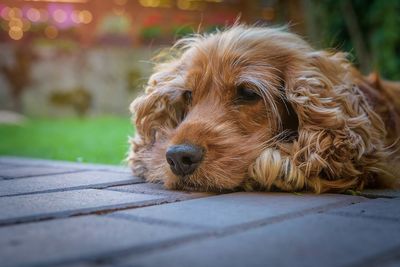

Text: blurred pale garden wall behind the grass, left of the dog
xmin=0 ymin=44 xmax=159 ymax=117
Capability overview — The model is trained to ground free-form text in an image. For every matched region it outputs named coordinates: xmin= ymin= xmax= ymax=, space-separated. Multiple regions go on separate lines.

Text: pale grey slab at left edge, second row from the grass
xmin=0 ymin=171 xmax=143 ymax=196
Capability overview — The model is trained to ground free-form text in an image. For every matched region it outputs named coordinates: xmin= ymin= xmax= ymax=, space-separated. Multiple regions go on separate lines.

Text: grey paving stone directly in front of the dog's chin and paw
xmin=115 ymin=192 xmax=365 ymax=228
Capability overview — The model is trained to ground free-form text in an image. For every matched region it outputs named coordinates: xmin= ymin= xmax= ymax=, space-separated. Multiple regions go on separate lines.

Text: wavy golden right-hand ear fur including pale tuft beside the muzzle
xmin=250 ymin=52 xmax=392 ymax=193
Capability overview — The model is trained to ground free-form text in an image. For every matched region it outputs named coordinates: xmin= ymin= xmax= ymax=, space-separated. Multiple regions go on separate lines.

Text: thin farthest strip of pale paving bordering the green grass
xmin=0 ymin=156 xmax=131 ymax=173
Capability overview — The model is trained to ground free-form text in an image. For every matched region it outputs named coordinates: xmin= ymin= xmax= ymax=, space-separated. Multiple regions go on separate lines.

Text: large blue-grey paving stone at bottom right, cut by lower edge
xmin=112 ymin=214 xmax=400 ymax=267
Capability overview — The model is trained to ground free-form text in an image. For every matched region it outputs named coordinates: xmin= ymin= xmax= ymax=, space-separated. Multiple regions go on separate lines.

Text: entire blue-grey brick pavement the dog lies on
xmin=0 ymin=157 xmax=400 ymax=267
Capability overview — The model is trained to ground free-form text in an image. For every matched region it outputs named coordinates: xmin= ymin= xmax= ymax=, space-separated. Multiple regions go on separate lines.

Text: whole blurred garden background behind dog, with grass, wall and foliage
xmin=0 ymin=0 xmax=400 ymax=164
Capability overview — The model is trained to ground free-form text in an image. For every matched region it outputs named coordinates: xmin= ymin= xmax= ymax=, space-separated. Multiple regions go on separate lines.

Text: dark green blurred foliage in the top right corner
xmin=308 ymin=0 xmax=400 ymax=79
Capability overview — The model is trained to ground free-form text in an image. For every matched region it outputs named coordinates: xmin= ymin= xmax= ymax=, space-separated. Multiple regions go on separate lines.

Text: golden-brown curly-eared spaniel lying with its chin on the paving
xmin=127 ymin=25 xmax=400 ymax=193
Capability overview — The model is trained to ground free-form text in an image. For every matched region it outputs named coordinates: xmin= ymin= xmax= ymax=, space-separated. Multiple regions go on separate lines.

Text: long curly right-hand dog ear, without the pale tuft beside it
xmin=285 ymin=52 xmax=385 ymax=192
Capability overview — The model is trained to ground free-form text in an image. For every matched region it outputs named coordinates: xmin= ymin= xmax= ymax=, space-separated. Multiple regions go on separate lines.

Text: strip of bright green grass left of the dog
xmin=0 ymin=117 xmax=133 ymax=164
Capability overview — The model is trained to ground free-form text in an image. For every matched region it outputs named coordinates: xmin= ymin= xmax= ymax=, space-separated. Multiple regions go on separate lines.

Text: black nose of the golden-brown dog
xmin=166 ymin=144 xmax=203 ymax=176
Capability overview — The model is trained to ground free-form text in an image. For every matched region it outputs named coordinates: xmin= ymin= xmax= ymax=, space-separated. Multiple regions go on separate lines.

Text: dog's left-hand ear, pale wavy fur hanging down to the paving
xmin=127 ymin=61 xmax=186 ymax=181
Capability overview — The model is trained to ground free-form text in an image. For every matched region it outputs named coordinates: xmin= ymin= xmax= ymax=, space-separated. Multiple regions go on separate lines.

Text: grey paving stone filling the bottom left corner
xmin=0 ymin=216 xmax=200 ymax=267
